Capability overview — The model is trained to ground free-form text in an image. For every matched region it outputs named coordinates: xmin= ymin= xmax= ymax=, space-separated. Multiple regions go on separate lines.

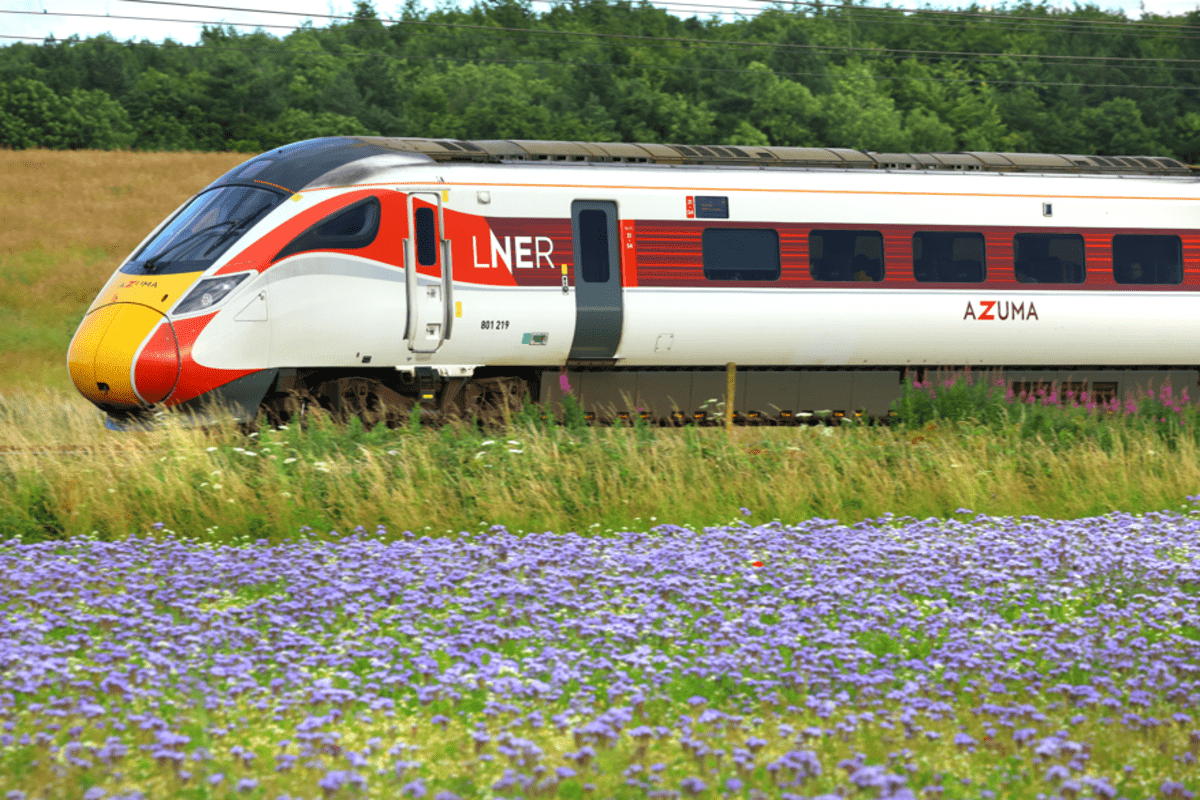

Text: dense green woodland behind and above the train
xmin=0 ymin=0 xmax=1200 ymax=162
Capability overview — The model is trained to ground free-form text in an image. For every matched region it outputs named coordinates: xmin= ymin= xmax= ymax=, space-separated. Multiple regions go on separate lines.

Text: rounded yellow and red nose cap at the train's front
xmin=67 ymin=302 xmax=180 ymax=408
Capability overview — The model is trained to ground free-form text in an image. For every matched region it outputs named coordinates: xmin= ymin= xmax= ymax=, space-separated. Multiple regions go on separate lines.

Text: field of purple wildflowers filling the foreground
xmin=0 ymin=509 xmax=1200 ymax=800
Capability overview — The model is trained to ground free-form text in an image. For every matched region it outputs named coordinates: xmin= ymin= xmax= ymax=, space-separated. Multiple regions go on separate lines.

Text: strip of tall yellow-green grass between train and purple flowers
xmin=0 ymin=383 xmax=1200 ymax=541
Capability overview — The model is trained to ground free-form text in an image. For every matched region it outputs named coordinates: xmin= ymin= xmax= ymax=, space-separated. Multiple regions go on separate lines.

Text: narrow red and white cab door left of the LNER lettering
xmin=404 ymin=191 xmax=454 ymax=353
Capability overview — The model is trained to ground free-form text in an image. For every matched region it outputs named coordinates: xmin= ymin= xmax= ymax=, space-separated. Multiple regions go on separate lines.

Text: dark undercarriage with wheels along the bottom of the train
xmin=157 ymin=365 xmax=1200 ymax=427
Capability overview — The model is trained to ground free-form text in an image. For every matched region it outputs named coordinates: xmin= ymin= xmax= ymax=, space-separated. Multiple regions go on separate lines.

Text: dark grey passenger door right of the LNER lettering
xmin=568 ymin=200 xmax=624 ymax=359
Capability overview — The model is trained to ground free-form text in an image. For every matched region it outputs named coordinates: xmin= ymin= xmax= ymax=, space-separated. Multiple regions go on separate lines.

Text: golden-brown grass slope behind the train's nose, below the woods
xmin=0 ymin=150 xmax=248 ymax=391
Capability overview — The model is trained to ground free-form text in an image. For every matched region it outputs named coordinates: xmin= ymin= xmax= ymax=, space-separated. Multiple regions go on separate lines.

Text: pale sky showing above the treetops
xmin=9 ymin=0 xmax=1200 ymax=44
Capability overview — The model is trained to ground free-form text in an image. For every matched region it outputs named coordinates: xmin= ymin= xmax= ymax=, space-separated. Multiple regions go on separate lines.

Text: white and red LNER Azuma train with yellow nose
xmin=67 ymin=137 xmax=1200 ymax=426
